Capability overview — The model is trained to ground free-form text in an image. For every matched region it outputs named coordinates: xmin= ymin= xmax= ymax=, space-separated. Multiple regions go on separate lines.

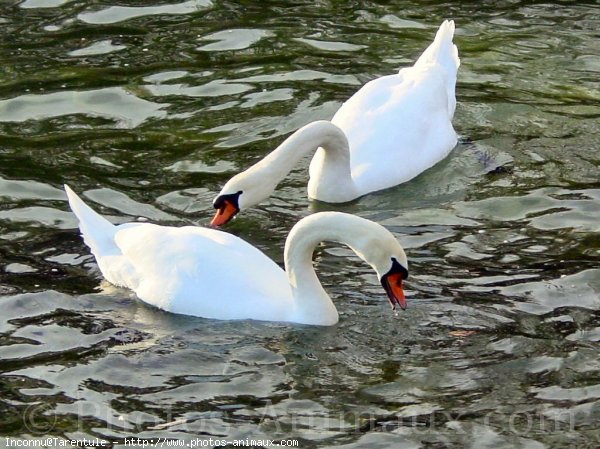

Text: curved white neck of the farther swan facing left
xmin=238 ymin=120 xmax=356 ymax=201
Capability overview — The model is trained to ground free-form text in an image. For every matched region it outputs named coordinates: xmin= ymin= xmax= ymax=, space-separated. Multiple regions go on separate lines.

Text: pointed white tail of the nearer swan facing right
xmin=64 ymin=184 xmax=120 ymax=260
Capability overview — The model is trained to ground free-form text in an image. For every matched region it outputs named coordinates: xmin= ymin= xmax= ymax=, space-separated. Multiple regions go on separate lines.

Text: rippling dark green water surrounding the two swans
xmin=0 ymin=0 xmax=600 ymax=449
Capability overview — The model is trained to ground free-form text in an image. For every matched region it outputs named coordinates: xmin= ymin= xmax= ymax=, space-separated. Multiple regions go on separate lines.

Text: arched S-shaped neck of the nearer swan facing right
xmin=284 ymin=212 xmax=380 ymax=325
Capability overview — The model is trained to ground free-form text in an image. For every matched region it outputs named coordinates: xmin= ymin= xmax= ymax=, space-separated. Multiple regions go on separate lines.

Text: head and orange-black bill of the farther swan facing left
xmin=210 ymin=170 xmax=276 ymax=226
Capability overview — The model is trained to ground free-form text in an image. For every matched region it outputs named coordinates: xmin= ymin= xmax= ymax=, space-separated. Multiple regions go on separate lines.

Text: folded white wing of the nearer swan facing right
xmin=115 ymin=224 xmax=291 ymax=321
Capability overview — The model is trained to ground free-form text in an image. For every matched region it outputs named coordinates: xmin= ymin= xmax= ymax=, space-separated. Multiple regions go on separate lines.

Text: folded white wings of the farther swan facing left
xmin=332 ymin=65 xmax=456 ymax=194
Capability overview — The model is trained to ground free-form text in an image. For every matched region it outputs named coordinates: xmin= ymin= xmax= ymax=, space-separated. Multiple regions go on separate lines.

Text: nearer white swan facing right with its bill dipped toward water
xmin=64 ymin=185 xmax=408 ymax=326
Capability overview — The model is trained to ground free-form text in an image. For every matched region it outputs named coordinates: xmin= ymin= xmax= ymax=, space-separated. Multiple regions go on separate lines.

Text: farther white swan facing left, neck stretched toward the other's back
xmin=211 ymin=20 xmax=460 ymax=226
